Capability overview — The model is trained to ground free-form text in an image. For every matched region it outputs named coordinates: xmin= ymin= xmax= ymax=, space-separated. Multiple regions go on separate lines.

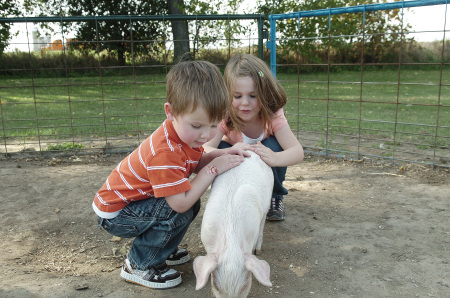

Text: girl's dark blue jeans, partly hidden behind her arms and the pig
xmin=217 ymin=136 xmax=288 ymax=200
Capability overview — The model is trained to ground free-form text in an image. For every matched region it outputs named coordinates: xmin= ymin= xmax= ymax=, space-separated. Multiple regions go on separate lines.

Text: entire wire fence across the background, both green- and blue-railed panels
xmin=0 ymin=1 xmax=450 ymax=167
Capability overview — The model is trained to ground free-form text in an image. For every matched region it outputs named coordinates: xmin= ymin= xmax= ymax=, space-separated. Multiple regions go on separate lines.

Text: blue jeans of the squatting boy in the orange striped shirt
xmin=98 ymin=198 xmax=200 ymax=270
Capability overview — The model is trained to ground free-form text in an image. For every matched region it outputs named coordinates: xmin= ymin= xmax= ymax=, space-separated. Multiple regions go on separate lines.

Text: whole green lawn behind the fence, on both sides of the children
xmin=0 ymin=65 xmax=450 ymax=148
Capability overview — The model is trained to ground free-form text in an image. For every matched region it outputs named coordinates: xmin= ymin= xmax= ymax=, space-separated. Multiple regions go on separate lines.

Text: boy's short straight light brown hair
xmin=166 ymin=61 xmax=230 ymax=122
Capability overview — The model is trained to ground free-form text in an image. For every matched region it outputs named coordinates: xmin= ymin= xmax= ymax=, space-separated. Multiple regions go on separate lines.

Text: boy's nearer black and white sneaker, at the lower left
xmin=120 ymin=258 xmax=181 ymax=289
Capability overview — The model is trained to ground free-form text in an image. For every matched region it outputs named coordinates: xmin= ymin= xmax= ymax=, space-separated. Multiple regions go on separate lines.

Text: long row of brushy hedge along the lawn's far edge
xmin=0 ymin=40 xmax=450 ymax=77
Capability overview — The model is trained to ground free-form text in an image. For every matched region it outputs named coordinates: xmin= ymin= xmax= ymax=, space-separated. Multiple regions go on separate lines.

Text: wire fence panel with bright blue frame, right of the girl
xmin=268 ymin=0 xmax=450 ymax=167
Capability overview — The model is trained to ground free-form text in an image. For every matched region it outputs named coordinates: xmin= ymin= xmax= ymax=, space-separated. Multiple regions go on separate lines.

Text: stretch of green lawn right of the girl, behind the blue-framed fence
xmin=277 ymin=68 xmax=450 ymax=148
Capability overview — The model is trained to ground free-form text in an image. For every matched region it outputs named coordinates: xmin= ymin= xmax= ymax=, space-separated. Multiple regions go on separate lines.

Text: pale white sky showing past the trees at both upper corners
xmin=7 ymin=4 xmax=450 ymax=51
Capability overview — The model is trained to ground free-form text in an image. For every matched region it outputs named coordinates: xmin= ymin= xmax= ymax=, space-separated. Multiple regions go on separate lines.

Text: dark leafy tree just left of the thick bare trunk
xmin=25 ymin=0 xmax=183 ymax=65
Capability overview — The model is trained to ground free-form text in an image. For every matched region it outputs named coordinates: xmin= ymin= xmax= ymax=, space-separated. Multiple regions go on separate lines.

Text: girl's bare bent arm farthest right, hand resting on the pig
xmin=252 ymin=125 xmax=304 ymax=167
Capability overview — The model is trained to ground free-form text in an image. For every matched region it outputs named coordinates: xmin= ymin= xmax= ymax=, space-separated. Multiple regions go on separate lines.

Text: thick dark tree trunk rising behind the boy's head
xmin=167 ymin=0 xmax=191 ymax=63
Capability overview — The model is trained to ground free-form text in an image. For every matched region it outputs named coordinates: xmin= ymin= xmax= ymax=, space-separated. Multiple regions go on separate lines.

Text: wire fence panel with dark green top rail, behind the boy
xmin=0 ymin=14 xmax=264 ymax=156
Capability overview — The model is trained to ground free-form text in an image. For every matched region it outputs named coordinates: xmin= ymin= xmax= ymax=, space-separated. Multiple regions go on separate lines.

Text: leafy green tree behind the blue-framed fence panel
xmin=258 ymin=0 xmax=409 ymax=62
